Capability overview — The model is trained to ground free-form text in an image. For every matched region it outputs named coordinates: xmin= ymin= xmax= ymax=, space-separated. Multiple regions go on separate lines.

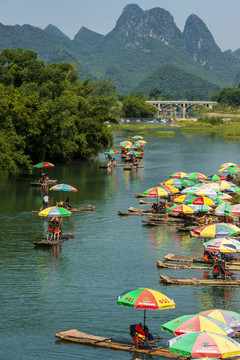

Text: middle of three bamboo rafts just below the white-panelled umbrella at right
xmin=157 ymin=260 xmax=240 ymax=271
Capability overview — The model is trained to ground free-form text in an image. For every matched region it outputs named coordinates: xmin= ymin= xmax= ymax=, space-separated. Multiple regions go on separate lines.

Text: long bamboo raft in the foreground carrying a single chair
xmin=55 ymin=329 xmax=184 ymax=360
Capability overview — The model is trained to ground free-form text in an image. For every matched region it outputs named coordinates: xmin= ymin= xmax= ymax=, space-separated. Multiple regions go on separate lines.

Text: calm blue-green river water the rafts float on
xmin=0 ymin=132 xmax=240 ymax=360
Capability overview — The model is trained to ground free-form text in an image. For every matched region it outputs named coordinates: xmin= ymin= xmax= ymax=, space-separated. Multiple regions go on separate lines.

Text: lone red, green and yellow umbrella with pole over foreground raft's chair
xmin=117 ymin=288 xmax=175 ymax=325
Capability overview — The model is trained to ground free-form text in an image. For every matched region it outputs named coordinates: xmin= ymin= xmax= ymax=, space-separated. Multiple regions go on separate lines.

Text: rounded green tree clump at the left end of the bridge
xmin=122 ymin=94 xmax=156 ymax=118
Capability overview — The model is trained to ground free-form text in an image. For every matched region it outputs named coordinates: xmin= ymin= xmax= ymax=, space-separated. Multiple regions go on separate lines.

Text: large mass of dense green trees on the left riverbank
xmin=0 ymin=49 xmax=117 ymax=173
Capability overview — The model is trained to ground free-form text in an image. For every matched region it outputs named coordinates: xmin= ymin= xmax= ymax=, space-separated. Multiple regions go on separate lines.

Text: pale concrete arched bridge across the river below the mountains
xmin=147 ymin=100 xmax=217 ymax=117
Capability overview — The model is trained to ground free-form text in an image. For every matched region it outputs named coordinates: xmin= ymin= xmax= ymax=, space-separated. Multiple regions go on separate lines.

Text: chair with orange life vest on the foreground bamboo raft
xmin=129 ymin=323 xmax=162 ymax=347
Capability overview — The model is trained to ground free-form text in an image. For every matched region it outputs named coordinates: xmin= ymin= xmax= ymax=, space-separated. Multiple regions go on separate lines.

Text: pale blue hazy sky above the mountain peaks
xmin=0 ymin=0 xmax=240 ymax=51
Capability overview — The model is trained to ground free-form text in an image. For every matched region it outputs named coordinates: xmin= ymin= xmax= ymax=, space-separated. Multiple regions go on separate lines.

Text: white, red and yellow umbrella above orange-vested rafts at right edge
xmin=203 ymin=238 xmax=240 ymax=253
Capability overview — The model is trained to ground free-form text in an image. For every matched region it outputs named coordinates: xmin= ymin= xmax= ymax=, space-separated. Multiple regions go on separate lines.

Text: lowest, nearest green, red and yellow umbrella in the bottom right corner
xmin=169 ymin=332 xmax=240 ymax=358
